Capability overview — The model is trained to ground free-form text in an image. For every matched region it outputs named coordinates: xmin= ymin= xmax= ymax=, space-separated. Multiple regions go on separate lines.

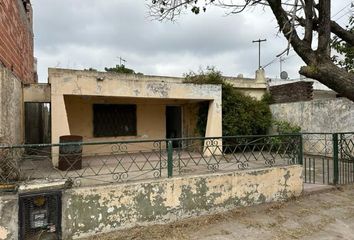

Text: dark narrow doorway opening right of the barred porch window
xmin=166 ymin=106 xmax=182 ymax=148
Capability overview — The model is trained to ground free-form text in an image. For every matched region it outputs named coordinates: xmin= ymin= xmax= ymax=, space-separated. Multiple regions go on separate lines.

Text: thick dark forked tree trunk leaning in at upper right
xmin=267 ymin=0 xmax=354 ymax=101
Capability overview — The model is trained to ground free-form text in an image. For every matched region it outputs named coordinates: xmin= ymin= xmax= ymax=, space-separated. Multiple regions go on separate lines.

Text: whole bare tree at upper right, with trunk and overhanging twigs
xmin=148 ymin=0 xmax=354 ymax=101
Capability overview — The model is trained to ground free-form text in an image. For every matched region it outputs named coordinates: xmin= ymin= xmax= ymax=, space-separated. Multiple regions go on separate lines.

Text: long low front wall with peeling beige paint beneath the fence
xmin=62 ymin=166 xmax=303 ymax=239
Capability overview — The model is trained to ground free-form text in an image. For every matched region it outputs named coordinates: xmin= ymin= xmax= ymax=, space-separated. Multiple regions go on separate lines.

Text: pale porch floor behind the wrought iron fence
xmin=21 ymin=151 xmax=293 ymax=186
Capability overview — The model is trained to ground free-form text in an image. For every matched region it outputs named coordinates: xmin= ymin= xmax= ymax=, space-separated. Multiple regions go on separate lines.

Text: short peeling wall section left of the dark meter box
xmin=0 ymin=194 xmax=18 ymax=240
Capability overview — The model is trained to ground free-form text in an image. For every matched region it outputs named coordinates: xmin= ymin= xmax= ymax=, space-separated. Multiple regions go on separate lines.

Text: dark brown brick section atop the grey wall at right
xmin=269 ymin=81 xmax=313 ymax=103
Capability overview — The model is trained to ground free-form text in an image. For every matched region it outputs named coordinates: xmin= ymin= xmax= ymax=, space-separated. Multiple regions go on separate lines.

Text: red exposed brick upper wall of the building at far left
xmin=0 ymin=0 xmax=35 ymax=83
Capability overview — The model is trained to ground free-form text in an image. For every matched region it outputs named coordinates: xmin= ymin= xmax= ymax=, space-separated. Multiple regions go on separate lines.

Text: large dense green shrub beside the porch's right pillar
xmin=184 ymin=68 xmax=272 ymax=136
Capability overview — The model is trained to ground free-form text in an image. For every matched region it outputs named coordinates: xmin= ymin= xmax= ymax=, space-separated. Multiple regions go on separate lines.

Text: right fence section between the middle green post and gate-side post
xmin=171 ymin=135 xmax=301 ymax=175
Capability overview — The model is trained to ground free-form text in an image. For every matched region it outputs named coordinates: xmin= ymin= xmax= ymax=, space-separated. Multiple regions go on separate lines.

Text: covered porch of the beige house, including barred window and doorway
xmin=49 ymin=69 xmax=222 ymax=166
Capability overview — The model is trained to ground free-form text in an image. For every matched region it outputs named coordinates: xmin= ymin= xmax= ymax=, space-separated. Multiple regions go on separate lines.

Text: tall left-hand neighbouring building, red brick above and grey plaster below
xmin=0 ymin=0 xmax=36 ymax=144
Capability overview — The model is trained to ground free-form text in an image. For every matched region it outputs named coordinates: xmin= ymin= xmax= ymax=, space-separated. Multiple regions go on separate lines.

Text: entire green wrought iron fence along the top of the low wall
xmin=0 ymin=134 xmax=302 ymax=188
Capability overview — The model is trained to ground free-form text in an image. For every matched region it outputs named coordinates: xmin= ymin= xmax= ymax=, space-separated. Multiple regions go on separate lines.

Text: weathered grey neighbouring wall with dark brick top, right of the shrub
xmin=269 ymin=78 xmax=354 ymax=133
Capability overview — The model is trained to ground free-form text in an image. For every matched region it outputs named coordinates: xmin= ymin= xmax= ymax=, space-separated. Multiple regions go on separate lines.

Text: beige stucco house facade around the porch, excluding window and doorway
xmin=49 ymin=69 xmax=222 ymax=163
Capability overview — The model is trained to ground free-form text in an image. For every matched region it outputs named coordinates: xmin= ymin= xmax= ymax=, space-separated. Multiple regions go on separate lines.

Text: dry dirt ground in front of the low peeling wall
xmin=90 ymin=186 xmax=354 ymax=240
